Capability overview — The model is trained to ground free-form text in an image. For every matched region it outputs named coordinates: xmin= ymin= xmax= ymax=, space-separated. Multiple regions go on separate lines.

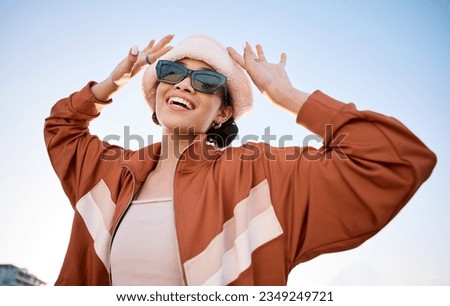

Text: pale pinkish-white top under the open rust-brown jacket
xmin=111 ymin=198 xmax=184 ymax=286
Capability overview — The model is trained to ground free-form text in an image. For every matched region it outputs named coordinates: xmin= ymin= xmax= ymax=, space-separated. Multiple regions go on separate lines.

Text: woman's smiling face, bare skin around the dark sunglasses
xmin=156 ymin=58 xmax=232 ymax=134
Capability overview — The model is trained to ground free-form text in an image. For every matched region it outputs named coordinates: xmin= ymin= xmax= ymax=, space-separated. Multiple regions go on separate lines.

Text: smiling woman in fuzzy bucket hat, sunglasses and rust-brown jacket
xmin=45 ymin=35 xmax=436 ymax=285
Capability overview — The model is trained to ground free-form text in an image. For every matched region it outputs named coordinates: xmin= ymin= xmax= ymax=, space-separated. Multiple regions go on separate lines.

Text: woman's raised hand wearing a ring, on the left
xmin=91 ymin=35 xmax=174 ymax=102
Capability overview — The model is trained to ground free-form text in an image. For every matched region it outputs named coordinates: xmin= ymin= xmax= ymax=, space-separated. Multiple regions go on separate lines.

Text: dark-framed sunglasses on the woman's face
xmin=156 ymin=60 xmax=227 ymax=97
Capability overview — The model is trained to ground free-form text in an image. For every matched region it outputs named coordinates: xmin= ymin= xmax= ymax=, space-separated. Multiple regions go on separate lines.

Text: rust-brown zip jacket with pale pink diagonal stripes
xmin=44 ymin=83 xmax=436 ymax=285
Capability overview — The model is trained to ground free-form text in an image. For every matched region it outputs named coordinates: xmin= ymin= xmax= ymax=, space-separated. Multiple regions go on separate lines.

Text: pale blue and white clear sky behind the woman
xmin=0 ymin=0 xmax=450 ymax=286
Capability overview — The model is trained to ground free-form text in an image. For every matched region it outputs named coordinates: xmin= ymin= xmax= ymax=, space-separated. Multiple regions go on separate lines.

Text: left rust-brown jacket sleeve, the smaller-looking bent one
xmin=44 ymin=82 xmax=126 ymax=206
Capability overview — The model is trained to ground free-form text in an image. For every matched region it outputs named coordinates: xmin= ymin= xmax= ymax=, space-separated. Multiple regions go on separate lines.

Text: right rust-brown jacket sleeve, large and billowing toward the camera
xmin=265 ymin=91 xmax=436 ymax=265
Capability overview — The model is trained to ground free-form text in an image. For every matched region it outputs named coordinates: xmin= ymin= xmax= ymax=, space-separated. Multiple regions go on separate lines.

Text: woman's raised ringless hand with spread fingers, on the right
xmin=227 ymin=42 xmax=308 ymax=113
